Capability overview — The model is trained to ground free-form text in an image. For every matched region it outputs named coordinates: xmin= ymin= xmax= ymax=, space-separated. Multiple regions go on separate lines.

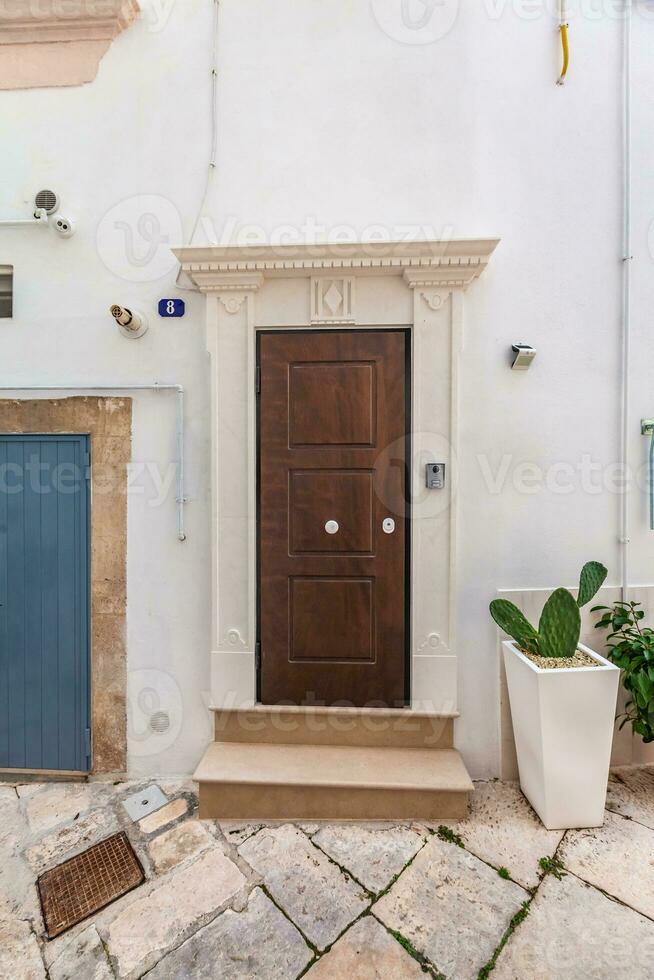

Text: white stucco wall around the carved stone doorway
xmin=0 ymin=0 xmax=654 ymax=775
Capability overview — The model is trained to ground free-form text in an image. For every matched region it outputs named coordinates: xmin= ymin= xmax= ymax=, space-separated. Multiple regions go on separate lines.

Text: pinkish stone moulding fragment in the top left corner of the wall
xmin=0 ymin=0 xmax=139 ymax=89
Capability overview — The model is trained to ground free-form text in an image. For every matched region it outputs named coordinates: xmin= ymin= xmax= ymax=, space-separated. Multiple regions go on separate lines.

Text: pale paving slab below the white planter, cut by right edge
xmin=559 ymin=813 xmax=654 ymax=918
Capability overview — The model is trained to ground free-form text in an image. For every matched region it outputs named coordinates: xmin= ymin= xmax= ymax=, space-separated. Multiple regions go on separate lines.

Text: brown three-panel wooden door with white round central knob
xmin=259 ymin=331 xmax=407 ymax=707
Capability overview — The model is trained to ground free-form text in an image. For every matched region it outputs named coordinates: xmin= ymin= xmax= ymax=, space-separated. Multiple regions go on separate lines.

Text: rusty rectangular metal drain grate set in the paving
xmin=36 ymin=833 xmax=145 ymax=939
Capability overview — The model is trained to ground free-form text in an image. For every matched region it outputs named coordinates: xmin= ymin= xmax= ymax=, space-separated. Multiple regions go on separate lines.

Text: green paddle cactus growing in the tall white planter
xmin=490 ymin=561 xmax=607 ymax=657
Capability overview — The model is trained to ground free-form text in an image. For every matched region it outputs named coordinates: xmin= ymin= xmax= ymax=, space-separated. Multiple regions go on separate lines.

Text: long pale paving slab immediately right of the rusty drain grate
xmin=102 ymin=850 xmax=246 ymax=978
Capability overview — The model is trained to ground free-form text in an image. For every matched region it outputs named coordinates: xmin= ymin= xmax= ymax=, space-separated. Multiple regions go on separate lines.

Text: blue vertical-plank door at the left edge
xmin=0 ymin=435 xmax=90 ymax=771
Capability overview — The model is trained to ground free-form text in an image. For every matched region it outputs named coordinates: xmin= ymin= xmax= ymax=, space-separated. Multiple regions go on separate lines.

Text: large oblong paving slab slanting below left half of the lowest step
xmin=238 ymin=824 xmax=370 ymax=949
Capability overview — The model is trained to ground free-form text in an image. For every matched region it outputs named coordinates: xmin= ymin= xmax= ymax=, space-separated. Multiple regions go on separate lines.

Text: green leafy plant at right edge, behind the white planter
xmin=591 ymin=602 xmax=654 ymax=742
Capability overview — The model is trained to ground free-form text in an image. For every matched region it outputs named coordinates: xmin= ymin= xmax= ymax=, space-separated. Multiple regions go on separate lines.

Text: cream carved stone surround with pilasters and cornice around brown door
xmin=175 ymin=240 xmax=497 ymax=714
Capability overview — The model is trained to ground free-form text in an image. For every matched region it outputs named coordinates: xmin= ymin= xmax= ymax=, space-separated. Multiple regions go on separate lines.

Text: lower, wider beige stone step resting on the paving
xmin=193 ymin=742 xmax=473 ymax=821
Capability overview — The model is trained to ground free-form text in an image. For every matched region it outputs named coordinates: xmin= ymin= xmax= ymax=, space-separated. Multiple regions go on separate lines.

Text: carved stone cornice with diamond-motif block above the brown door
xmin=173 ymin=238 xmax=498 ymax=292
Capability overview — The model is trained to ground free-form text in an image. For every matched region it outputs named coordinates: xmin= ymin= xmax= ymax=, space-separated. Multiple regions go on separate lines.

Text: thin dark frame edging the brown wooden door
xmin=255 ymin=325 xmax=413 ymax=707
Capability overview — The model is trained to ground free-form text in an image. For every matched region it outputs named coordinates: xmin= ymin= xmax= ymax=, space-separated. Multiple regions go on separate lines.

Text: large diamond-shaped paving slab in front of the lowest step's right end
xmin=372 ymin=837 xmax=529 ymax=980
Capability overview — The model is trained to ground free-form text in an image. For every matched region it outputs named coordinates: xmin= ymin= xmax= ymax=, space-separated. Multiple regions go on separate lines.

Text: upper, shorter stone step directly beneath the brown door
xmin=214 ymin=705 xmax=457 ymax=749
